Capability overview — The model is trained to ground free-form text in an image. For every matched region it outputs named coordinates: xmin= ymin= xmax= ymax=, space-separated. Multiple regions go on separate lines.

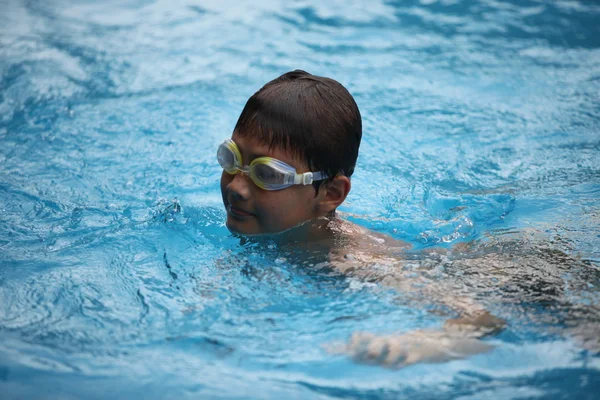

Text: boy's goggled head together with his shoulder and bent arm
xmin=217 ymin=70 xmax=502 ymax=365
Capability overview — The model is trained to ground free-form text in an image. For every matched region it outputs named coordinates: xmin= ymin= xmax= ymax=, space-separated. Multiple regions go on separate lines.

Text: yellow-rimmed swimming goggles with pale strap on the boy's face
xmin=217 ymin=139 xmax=327 ymax=190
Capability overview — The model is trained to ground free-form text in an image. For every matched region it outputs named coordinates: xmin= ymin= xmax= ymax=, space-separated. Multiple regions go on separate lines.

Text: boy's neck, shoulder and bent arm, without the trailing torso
xmin=237 ymin=215 xmax=505 ymax=367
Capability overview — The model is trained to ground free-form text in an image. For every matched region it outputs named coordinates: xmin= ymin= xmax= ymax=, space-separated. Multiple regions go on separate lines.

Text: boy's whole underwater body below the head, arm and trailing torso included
xmin=237 ymin=216 xmax=600 ymax=367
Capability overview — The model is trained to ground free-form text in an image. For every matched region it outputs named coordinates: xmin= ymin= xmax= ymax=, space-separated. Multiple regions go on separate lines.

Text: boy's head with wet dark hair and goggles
xmin=220 ymin=70 xmax=362 ymax=234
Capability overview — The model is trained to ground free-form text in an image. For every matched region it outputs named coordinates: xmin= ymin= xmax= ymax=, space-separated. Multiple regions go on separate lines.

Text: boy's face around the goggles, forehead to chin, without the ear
xmin=221 ymin=132 xmax=321 ymax=235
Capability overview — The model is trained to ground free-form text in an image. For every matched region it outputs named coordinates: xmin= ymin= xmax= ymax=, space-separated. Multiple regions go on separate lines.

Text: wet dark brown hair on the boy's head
xmin=235 ymin=70 xmax=362 ymax=189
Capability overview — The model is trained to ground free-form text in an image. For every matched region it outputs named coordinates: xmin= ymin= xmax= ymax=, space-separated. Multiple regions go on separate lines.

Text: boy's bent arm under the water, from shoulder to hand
xmin=331 ymin=222 xmax=505 ymax=367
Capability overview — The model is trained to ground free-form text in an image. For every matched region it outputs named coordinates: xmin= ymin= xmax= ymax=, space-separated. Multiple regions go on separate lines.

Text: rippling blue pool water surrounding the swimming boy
xmin=0 ymin=0 xmax=600 ymax=399
